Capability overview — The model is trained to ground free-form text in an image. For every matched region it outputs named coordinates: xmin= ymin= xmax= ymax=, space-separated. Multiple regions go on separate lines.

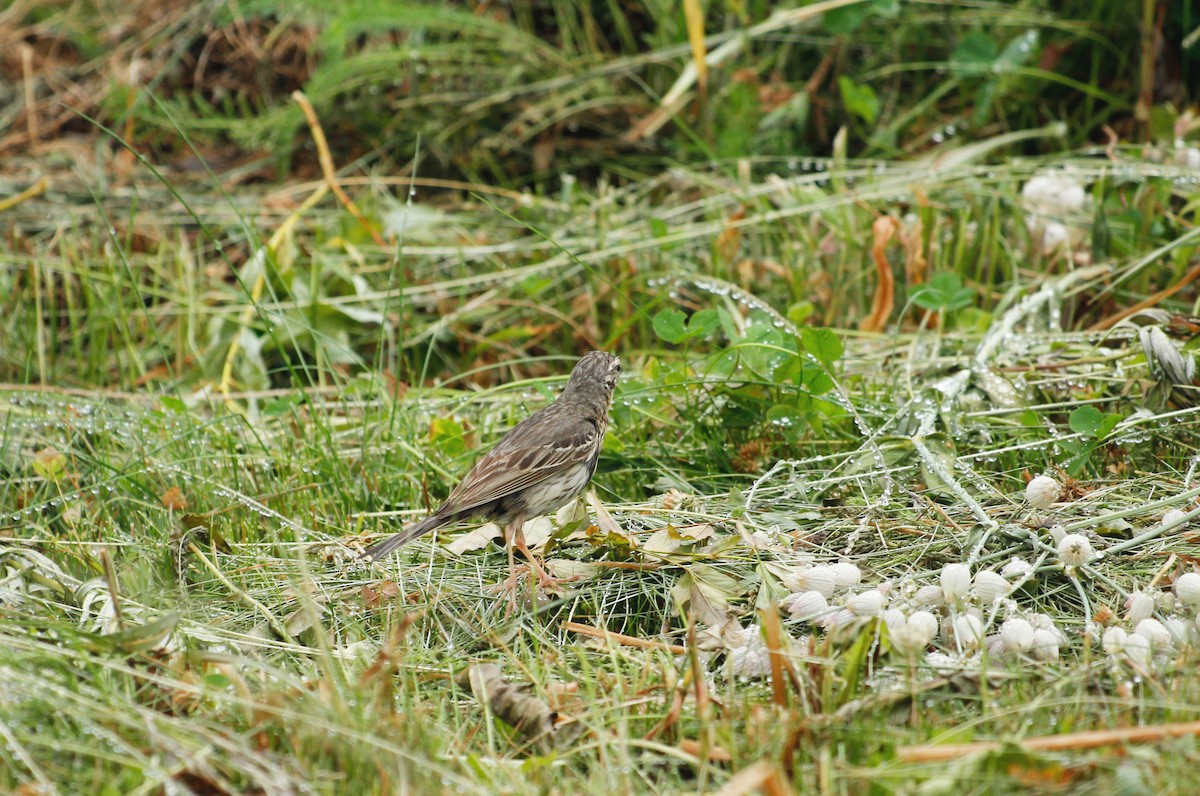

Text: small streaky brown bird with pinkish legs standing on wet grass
xmin=362 ymin=351 xmax=620 ymax=595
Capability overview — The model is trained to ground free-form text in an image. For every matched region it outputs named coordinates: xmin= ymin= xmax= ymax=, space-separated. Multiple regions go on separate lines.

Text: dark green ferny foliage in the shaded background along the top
xmin=60 ymin=0 xmax=1166 ymax=177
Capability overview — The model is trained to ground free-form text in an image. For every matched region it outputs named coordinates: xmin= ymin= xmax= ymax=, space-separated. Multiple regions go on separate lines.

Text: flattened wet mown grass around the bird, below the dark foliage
xmin=0 ymin=144 xmax=1200 ymax=792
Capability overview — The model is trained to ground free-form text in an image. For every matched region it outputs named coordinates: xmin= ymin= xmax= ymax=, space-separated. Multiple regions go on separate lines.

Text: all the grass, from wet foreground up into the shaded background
xmin=0 ymin=4 xmax=1200 ymax=794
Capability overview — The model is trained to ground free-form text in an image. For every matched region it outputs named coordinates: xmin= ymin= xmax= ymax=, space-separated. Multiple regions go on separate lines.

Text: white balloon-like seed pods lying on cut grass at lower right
xmin=763 ymin=475 xmax=1200 ymax=668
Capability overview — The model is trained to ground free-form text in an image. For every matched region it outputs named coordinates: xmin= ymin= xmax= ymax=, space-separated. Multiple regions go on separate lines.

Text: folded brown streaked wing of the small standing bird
xmin=443 ymin=417 xmax=600 ymax=514
